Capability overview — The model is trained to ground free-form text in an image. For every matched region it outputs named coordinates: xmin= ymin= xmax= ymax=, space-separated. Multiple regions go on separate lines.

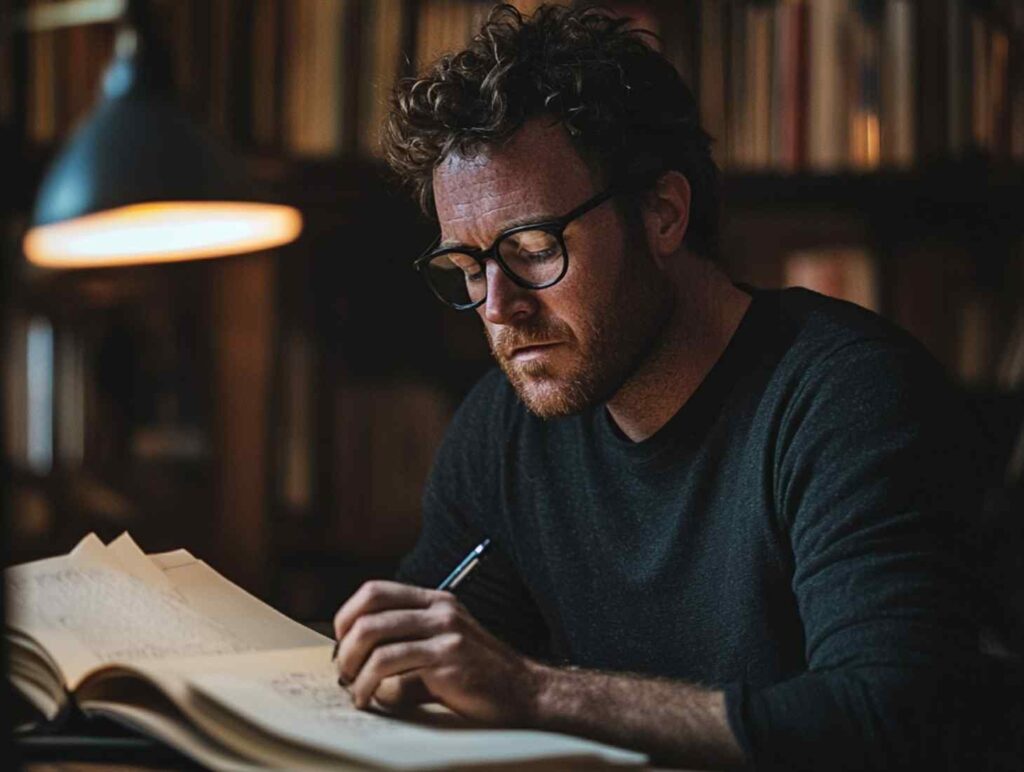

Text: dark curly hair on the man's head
xmin=382 ymin=0 xmax=719 ymax=258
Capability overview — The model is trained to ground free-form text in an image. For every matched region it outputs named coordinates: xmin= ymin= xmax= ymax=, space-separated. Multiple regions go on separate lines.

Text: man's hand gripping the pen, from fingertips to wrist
xmin=334 ymin=582 xmax=537 ymax=726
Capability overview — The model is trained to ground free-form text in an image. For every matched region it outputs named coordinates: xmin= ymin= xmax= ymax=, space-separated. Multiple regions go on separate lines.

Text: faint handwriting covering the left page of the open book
xmin=7 ymin=567 xmax=252 ymax=662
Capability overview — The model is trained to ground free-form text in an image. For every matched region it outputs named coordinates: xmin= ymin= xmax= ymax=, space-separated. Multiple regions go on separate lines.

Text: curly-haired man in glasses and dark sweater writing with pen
xmin=335 ymin=7 xmax=1003 ymax=769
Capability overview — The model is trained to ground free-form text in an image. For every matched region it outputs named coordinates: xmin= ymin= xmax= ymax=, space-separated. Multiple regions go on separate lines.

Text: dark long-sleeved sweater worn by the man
xmin=398 ymin=285 xmax=1007 ymax=770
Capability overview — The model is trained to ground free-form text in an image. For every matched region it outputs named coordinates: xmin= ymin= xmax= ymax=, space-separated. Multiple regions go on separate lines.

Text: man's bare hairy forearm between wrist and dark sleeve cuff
xmin=528 ymin=664 xmax=743 ymax=769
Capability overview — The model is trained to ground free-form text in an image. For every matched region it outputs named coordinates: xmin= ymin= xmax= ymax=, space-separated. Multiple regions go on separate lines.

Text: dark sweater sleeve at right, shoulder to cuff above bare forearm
xmin=726 ymin=340 xmax=985 ymax=770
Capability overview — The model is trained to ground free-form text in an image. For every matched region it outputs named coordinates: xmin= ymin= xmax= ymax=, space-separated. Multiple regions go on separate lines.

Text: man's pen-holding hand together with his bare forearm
xmin=334 ymin=582 xmax=743 ymax=768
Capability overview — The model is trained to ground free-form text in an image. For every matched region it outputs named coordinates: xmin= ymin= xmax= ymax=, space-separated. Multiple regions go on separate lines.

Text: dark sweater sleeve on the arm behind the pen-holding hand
xmin=396 ymin=372 xmax=548 ymax=656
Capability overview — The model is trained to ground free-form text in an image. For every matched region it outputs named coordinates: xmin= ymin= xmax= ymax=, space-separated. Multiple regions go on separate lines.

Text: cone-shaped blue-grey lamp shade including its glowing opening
xmin=24 ymin=29 xmax=302 ymax=267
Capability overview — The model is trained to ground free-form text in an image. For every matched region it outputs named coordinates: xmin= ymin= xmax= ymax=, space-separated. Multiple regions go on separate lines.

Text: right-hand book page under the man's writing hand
xmin=140 ymin=646 xmax=646 ymax=769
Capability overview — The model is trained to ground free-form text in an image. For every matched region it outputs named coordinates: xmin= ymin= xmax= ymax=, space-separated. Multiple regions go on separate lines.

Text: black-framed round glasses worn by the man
xmin=413 ymin=185 xmax=622 ymax=311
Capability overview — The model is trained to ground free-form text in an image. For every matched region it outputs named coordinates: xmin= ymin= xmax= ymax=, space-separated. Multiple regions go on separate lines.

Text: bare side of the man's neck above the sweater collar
xmin=607 ymin=260 xmax=751 ymax=442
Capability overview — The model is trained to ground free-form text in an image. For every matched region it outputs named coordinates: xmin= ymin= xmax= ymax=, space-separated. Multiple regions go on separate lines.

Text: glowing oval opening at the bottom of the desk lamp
xmin=24 ymin=201 xmax=302 ymax=268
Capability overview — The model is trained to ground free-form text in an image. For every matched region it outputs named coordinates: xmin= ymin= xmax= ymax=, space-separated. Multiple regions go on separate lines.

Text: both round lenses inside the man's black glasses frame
xmin=427 ymin=230 xmax=565 ymax=306
